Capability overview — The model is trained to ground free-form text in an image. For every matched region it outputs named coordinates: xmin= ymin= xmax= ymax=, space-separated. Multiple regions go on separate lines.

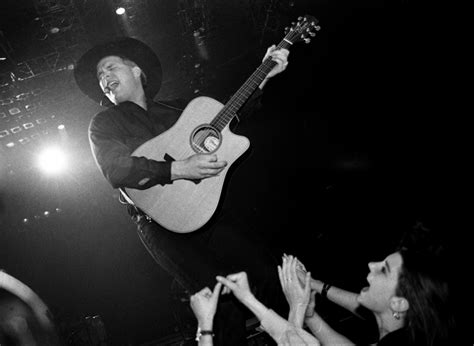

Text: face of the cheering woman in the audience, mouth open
xmin=357 ymin=252 xmax=403 ymax=312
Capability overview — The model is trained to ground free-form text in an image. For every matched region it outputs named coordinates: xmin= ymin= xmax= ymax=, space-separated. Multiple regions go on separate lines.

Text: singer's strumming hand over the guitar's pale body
xmin=171 ymin=154 xmax=227 ymax=180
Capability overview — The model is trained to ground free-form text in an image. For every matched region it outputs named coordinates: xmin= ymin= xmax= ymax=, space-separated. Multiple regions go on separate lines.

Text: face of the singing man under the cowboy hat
xmin=97 ymin=56 xmax=141 ymax=104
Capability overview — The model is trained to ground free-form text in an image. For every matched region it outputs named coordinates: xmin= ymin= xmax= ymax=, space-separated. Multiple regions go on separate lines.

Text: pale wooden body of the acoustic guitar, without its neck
xmin=125 ymin=97 xmax=250 ymax=233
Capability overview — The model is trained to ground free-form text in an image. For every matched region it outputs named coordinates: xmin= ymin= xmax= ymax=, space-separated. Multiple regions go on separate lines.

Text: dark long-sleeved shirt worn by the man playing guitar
xmin=89 ymin=89 xmax=262 ymax=190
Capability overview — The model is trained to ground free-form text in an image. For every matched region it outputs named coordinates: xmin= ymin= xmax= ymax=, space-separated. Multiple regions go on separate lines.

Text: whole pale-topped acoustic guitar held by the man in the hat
xmin=125 ymin=15 xmax=320 ymax=233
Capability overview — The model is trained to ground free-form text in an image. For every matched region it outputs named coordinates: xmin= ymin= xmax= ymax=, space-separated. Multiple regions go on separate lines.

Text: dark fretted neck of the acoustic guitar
xmin=211 ymin=38 xmax=292 ymax=131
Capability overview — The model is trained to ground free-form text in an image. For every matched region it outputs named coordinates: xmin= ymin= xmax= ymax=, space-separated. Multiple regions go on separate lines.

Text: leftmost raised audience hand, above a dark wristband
xmin=190 ymin=282 xmax=222 ymax=329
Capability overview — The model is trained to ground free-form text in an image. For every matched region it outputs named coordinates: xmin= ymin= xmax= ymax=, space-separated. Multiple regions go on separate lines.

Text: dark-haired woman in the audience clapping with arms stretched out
xmin=279 ymin=226 xmax=454 ymax=346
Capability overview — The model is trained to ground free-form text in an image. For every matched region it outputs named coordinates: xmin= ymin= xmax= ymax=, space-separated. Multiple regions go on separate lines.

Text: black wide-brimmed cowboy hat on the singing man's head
xmin=74 ymin=37 xmax=162 ymax=104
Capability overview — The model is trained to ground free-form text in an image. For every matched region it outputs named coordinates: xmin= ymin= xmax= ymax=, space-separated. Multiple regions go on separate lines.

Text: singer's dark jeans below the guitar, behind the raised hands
xmin=131 ymin=208 xmax=285 ymax=345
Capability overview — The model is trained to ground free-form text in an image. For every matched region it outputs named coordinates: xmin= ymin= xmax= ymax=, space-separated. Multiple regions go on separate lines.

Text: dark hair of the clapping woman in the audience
xmin=396 ymin=224 xmax=454 ymax=346
